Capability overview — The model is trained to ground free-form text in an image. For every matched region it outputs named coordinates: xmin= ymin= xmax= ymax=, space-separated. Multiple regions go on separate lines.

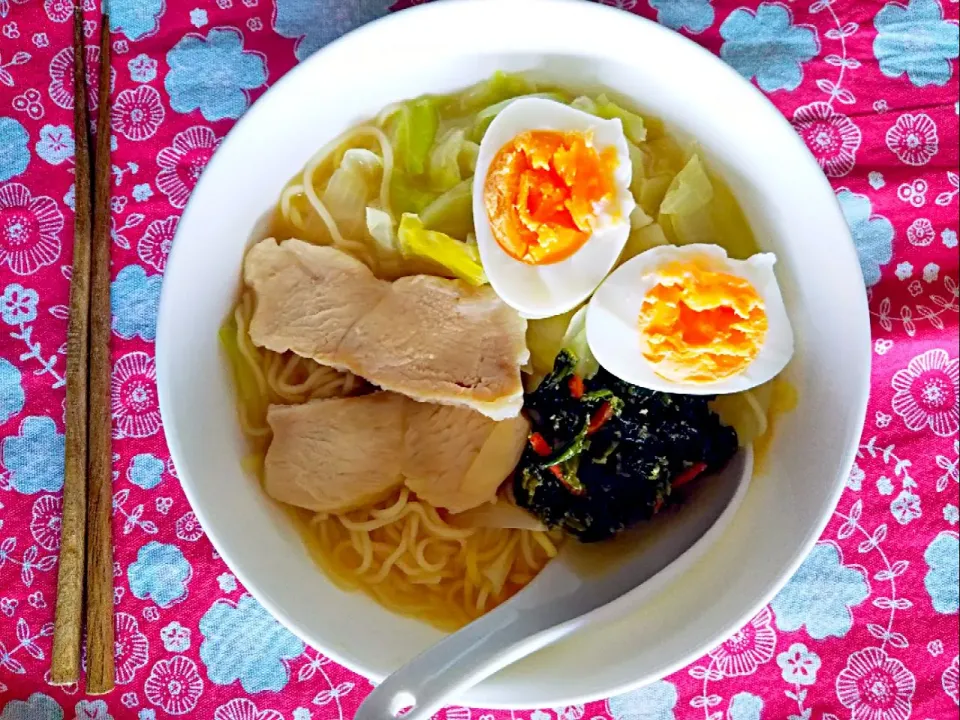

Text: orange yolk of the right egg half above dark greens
xmin=640 ymin=263 xmax=767 ymax=383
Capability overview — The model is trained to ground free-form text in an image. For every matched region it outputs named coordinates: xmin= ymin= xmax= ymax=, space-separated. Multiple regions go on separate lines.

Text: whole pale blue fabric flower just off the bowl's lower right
xmin=770 ymin=543 xmax=870 ymax=640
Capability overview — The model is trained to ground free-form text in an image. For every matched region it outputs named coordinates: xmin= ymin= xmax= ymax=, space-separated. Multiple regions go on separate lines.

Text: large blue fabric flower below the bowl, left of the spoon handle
xmin=200 ymin=595 xmax=304 ymax=693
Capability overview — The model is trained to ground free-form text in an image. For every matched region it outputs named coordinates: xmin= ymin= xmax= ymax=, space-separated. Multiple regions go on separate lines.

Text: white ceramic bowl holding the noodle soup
xmin=157 ymin=0 xmax=870 ymax=707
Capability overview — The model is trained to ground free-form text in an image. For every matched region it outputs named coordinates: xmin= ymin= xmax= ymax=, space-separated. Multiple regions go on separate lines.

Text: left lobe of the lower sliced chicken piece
xmin=264 ymin=393 xmax=409 ymax=513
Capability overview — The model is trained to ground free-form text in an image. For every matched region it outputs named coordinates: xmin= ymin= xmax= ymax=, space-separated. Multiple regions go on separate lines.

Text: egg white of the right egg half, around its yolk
xmin=587 ymin=245 xmax=793 ymax=395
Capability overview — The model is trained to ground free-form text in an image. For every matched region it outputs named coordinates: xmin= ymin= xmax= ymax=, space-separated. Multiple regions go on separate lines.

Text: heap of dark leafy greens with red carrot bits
xmin=513 ymin=351 xmax=737 ymax=542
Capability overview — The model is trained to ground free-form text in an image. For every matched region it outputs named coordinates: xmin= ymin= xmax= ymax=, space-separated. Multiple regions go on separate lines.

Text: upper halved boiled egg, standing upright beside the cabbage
xmin=473 ymin=98 xmax=636 ymax=318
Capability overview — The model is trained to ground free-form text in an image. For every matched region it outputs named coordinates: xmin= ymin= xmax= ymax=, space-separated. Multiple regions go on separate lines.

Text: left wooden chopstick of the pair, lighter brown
xmin=50 ymin=6 xmax=92 ymax=685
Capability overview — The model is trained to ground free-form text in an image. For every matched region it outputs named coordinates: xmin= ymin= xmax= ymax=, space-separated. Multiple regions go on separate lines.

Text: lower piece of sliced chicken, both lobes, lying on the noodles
xmin=265 ymin=392 xmax=529 ymax=513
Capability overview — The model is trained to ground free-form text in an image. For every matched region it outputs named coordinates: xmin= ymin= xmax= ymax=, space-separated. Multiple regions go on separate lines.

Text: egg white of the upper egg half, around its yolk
xmin=473 ymin=97 xmax=636 ymax=319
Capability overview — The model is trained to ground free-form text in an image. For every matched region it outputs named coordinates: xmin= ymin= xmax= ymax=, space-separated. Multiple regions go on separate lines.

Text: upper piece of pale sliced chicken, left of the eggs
xmin=245 ymin=238 xmax=529 ymax=420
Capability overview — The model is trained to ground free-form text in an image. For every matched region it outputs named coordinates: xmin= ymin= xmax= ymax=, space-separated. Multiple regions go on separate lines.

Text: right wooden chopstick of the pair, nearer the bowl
xmin=87 ymin=14 xmax=114 ymax=695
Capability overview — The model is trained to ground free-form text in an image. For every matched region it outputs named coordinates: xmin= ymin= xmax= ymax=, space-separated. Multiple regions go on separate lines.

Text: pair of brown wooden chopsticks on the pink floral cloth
xmin=50 ymin=7 xmax=114 ymax=695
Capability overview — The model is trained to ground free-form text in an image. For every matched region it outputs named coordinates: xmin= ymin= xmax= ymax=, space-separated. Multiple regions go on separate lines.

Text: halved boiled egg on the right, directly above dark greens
xmin=587 ymin=245 xmax=793 ymax=395
